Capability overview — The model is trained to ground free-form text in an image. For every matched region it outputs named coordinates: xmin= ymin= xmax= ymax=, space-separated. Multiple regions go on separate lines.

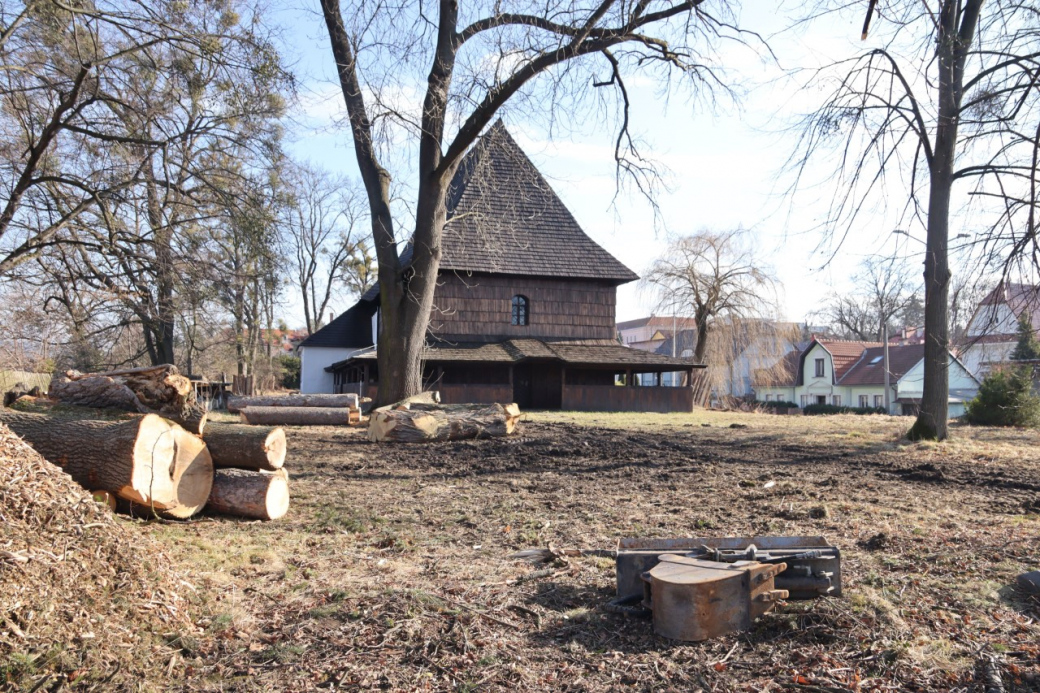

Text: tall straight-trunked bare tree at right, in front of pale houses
xmin=797 ymin=0 xmax=1040 ymax=440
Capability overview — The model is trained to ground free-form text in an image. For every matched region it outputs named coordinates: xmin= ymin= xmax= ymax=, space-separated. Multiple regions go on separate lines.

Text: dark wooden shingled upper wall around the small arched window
xmin=430 ymin=273 xmax=617 ymax=341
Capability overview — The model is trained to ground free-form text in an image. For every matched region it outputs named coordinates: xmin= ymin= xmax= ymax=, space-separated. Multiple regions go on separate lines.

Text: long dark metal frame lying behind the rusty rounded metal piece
xmin=616 ymin=537 xmax=841 ymax=599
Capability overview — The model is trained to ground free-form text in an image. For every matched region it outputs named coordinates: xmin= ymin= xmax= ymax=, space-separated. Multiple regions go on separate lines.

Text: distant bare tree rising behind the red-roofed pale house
xmin=821 ymin=257 xmax=920 ymax=341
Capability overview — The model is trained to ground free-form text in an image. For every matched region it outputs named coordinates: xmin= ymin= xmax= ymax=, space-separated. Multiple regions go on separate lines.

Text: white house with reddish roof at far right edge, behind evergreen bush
xmin=958 ymin=282 xmax=1040 ymax=380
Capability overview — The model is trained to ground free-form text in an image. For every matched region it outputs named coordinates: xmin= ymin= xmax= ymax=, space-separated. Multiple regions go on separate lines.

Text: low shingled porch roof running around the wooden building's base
xmin=326 ymin=338 xmax=704 ymax=371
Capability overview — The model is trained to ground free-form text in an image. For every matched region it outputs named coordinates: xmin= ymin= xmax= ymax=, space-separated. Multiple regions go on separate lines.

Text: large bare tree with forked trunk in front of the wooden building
xmin=321 ymin=0 xmax=761 ymax=402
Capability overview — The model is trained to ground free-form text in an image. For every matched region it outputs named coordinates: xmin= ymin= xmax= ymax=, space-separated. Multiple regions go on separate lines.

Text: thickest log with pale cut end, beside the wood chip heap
xmin=0 ymin=410 xmax=213 ymax=518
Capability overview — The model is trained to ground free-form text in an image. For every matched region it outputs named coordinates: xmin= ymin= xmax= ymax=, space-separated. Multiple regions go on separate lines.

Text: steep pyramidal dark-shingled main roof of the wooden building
xmin=441 ymin=121 xmax=639 ymax=284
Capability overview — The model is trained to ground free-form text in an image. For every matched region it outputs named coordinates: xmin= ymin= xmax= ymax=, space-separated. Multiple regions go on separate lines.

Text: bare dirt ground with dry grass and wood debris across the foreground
xmin=141 ymin=412 xmax=1040 ymax=692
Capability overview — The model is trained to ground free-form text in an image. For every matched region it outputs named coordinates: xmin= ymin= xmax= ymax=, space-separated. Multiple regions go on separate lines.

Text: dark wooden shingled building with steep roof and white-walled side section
xmin=300 ymin=122 xmax=703 ymax=411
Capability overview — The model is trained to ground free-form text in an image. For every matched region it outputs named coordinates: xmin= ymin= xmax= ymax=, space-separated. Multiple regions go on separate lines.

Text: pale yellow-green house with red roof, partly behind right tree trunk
xmin=755 ymin=337 xmax=979 ymax=416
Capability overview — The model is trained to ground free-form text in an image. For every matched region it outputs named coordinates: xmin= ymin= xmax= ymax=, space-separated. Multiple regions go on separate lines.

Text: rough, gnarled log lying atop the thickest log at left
xmin=49 ymin=364 xmax=206 ymax=435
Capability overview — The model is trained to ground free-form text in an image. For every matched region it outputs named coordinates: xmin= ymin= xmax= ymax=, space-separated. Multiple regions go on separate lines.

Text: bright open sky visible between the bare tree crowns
xmin=270 ymin=0 xmax=955 ymax=323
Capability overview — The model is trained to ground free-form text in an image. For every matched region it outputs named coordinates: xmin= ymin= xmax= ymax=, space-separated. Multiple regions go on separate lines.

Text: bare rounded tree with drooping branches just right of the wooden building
xmin=643 ymin=229 xmax=778 ymax=363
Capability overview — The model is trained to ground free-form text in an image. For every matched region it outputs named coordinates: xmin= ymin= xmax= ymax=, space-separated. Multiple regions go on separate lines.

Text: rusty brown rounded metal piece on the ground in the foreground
xmin=642 ymin=554 xmax=787 ymax=642
